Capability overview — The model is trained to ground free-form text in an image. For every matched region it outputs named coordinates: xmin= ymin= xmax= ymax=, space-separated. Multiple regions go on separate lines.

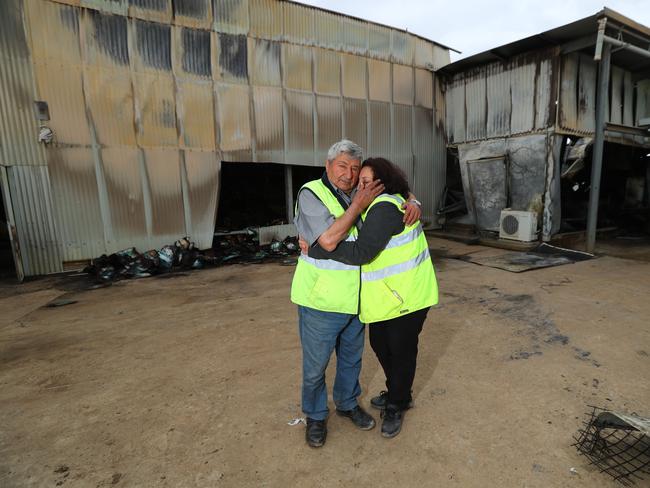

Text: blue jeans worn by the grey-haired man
xmin=298 ymin=305 xmax=365 ymax=420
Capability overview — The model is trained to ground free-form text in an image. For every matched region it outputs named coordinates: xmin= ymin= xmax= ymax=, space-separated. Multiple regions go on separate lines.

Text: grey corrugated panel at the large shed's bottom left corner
xmin=7 ymin=166 xmax=63 ymax=276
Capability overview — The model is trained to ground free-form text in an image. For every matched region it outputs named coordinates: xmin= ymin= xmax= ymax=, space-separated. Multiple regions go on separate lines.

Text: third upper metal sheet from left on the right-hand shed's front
xmin=487 ymin=63 xmax=512 ymax=137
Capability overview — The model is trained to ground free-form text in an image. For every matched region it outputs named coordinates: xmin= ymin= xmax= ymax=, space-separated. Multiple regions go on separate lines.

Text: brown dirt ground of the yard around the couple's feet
xmin=0 ymin=239 xmax=650 ymax=488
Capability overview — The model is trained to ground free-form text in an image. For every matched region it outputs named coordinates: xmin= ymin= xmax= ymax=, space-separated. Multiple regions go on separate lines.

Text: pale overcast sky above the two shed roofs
xmin=299 ymin=0 xmax=650 ymax=61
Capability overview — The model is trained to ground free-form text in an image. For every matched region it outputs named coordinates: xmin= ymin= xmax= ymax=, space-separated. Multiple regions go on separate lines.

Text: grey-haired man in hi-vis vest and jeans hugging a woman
xmin=291 ymin=139 xmax=420 ymax=447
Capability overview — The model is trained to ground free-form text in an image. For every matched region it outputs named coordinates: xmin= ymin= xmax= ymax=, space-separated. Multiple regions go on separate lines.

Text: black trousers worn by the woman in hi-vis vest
xmin=369 ymin=307 xmax=429 ymax=409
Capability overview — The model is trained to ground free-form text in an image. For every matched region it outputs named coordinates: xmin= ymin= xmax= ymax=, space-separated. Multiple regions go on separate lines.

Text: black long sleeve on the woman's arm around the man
xmin=309 ymin=202 xmax=404 ymax=266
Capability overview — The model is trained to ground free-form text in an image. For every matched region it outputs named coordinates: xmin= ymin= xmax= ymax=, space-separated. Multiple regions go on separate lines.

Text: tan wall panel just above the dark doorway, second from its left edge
xmin=253 ymin=86 xmax=284 ymax=163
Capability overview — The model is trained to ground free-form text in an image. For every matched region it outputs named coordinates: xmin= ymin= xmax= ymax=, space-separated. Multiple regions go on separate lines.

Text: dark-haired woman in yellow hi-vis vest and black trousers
xmin=309 ymin=158 xmax=438 ymax=437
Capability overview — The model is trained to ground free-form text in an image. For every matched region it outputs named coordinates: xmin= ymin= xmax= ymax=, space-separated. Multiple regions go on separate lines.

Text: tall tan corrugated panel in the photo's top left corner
xmin=0 ymin=0 xmax=45 ymax=166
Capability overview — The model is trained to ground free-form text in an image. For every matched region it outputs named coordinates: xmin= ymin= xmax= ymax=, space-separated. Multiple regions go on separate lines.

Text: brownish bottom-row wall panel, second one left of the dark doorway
xmin=144 ymin=149 xmax=185 ymax=242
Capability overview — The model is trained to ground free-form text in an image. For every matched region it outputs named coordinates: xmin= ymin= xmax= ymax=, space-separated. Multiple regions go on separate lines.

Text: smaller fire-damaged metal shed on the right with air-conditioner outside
xmin=437 ymin=8 xmax=650 ymax=251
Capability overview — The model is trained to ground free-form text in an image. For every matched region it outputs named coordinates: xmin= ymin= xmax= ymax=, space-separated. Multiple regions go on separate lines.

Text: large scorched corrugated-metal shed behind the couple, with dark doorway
xmin=0 ymin=0 xmax=449 ymax=277
